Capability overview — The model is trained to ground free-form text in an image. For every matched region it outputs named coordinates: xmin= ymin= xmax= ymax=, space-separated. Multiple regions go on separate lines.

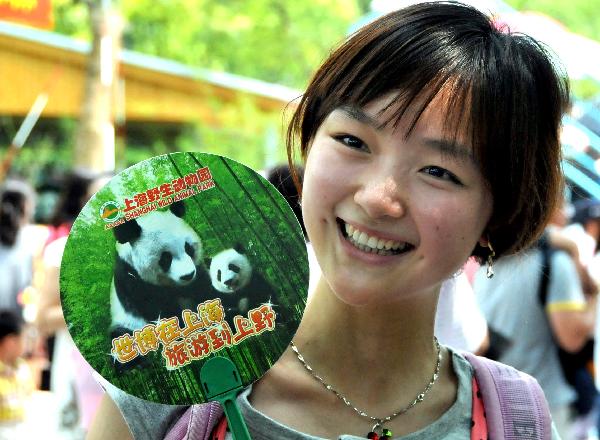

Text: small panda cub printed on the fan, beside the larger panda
xmin=209 ymin=245 xmax=275 ymax=331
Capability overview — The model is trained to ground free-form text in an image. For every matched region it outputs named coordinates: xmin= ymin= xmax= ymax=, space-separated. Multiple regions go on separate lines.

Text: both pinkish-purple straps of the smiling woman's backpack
xmin=165 ymin=353 xmax=552 ymax=440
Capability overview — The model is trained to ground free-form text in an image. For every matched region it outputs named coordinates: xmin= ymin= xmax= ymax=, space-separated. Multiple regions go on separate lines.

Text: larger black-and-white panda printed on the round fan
xmin=110 ymin=201 xmax=212 ymax=338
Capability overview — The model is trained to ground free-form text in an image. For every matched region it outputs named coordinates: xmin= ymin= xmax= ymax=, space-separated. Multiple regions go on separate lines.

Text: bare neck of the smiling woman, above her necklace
xmin=294 ymin=280 xmax=437 ymax=410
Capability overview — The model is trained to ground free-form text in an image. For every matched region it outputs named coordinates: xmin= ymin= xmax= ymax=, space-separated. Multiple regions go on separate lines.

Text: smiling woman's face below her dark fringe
xmin=302 ymin=96 xmax=492 ymax=305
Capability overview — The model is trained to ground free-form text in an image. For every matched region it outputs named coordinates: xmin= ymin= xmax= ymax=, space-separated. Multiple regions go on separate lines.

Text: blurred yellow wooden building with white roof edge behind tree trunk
xmin=0 ymin=21 xmax=299 ymax=123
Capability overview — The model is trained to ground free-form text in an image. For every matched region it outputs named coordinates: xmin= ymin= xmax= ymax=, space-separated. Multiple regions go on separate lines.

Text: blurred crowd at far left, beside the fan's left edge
xmin=0 ymin=170 xmax=108 ymax=439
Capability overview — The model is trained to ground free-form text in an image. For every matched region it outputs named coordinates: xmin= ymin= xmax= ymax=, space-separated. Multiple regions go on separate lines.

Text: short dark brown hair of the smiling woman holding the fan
xmin=287 ymin=2 xmax=569 ymax=261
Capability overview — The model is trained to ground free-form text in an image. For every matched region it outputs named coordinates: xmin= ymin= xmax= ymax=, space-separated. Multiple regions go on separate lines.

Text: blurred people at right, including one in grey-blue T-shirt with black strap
xmin=473 ymin=200 xmax=600 ymax=440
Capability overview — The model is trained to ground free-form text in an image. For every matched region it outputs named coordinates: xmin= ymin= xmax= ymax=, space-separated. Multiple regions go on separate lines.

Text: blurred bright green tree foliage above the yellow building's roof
xmin=53 ymin=0 xmax=356 ymax=88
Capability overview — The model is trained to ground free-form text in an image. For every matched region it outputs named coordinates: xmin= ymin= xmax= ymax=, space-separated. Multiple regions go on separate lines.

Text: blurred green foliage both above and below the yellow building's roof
xmin=53 ymin=0 xmax=356 ymax=169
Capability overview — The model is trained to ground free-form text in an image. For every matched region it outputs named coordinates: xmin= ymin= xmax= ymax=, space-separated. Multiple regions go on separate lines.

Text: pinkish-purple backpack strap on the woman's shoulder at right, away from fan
xmin=462 ymin=353 xmax=552 ymax=440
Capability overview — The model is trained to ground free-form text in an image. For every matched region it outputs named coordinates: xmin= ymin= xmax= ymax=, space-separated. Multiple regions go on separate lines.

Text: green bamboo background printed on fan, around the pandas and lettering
xmin=60 ymin=153 xmax=308 ymax=404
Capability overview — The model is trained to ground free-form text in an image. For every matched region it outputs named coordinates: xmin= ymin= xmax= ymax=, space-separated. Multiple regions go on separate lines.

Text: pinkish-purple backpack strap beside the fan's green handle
xmin=165 ymin=402 xmax=223 ymax=440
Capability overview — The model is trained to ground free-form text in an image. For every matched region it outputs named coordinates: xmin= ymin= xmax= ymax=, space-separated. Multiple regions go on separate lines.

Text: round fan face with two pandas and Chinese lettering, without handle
xmin=60 ymin=153 xmax=308 ymax=404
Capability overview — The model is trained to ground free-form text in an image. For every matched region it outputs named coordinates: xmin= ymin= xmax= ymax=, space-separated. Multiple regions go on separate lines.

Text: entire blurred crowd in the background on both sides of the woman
xmin=0 ymin=165 xmax=600 ymax=440
